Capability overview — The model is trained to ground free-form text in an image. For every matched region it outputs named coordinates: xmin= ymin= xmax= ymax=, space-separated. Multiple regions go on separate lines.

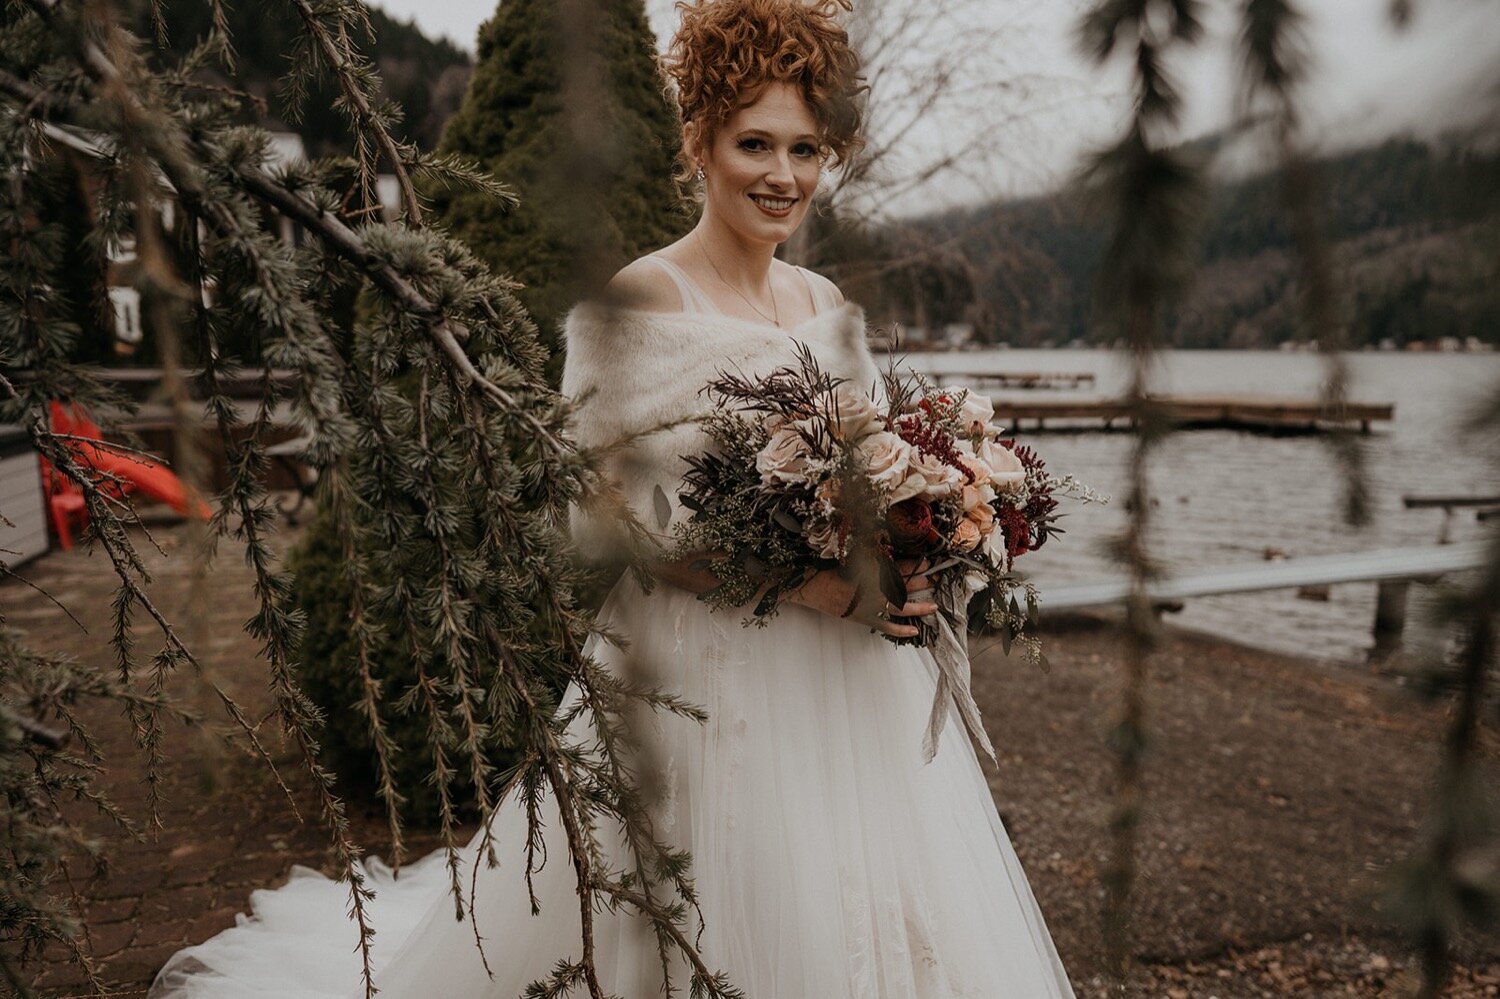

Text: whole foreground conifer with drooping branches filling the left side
xmin=0 ymin=0 xmax=738 ymax=999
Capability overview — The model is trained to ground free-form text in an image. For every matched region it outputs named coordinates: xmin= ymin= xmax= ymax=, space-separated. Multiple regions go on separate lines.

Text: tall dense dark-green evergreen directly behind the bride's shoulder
xmin=434 ymin=0 xmax=690 ymax=380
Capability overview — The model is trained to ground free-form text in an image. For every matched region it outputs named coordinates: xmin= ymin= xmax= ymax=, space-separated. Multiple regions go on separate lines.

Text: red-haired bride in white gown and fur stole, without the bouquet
xmin=150 ymin=0 xmax=1073 ymax=999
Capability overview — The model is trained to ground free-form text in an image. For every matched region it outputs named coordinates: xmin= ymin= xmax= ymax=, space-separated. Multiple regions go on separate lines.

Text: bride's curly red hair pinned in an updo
xmin=662 ymin=0 xmax=867 ymax=180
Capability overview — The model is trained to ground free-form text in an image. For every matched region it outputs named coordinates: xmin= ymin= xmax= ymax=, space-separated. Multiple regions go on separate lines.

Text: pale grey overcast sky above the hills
xmin=377 ymin=0 xmax=1500 ymax=209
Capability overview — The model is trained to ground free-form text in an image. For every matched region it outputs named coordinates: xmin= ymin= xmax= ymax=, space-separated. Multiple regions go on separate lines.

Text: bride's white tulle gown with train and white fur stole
xmin=150 ymin=258 xmax=1073 ymax=999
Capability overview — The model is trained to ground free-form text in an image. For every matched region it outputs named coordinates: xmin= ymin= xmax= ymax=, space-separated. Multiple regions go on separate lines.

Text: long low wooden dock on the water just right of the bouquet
xmin=995 ymin=396 xmax=1395 ymax=434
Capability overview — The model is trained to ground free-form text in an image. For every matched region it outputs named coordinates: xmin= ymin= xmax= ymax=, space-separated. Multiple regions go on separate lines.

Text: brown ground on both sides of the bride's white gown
xmin=11 ymin=516 xmax=1500 ymax=999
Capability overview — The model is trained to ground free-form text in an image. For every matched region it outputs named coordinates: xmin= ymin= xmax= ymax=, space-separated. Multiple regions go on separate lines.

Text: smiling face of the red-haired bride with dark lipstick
xmin=690 ymin=83 xmax=822 ymax=243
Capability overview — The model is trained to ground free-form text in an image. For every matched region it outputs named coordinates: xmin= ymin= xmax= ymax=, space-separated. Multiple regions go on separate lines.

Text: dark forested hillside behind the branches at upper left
xmin=137 ymin=0 xmax=471 ymax=156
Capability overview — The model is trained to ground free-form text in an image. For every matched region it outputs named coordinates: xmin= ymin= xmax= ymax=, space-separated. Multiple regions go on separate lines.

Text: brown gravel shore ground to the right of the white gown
xmin=975 ymin=620 xmax=1500 ymax=999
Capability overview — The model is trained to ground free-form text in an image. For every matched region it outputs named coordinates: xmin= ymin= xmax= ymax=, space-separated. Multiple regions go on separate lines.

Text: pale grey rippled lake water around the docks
xmin=906 ymin=350 xmax=1500 ymax=663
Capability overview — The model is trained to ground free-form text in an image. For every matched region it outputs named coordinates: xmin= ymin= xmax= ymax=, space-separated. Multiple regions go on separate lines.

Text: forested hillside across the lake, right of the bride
xmin=878 ymin=141 xmax=1500 ymax=347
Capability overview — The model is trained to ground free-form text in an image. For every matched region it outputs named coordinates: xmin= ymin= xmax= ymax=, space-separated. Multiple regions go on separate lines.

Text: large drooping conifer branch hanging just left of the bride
xmin=0 ymin=0 xmax=750 ymax=996
